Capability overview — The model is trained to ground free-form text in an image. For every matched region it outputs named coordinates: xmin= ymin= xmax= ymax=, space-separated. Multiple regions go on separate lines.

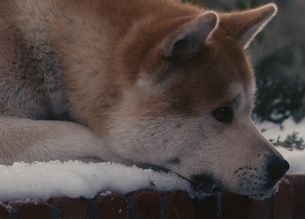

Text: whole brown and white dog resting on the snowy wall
xmin=0 ymin=0 xmax=289 ymax=195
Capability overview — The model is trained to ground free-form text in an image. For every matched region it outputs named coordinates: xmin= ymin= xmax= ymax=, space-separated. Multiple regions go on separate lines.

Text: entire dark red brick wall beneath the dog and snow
xmin=0 ymin=176 xmax=305 ymax=219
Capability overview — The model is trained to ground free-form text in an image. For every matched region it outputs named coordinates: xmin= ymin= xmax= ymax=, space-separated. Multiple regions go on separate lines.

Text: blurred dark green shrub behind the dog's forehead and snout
xmin=255 ymin=46 xmax=305 ymax=123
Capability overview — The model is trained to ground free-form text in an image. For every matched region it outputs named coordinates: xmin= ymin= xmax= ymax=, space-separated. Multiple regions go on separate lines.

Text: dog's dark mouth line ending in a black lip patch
xmin=136 ymin=163 xmax=223 ymax=194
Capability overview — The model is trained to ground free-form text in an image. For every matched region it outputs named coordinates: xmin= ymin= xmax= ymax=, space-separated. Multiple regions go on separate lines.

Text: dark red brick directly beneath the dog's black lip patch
xmin=194 ymin=196 xmax=219 ymax=219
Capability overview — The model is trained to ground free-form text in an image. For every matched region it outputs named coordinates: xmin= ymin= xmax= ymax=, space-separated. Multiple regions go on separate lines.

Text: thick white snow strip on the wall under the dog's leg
xmin=0 ymin=161 xmax=191 ymax=201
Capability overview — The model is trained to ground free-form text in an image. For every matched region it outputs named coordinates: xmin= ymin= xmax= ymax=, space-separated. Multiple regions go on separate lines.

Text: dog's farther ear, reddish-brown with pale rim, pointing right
xmin=220 ymin=3 xmax=277 ymax=49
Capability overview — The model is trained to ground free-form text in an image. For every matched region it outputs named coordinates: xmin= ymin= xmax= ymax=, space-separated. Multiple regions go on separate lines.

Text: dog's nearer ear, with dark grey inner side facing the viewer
xmin=161 ymin=11 xmax=219 ymax=59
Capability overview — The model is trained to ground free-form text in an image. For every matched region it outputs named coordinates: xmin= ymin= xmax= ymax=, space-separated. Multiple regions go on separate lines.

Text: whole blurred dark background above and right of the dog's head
xmin=185 ymin=0 xmax=305 ymax=124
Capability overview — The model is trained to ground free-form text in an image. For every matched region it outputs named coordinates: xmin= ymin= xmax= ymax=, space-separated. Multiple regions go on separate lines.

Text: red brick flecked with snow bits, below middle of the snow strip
xmin=97 ymin=193 xmax=128 ymax=219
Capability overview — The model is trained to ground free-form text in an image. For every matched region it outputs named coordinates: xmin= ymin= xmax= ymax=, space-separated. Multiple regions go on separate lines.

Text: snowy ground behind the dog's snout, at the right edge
xmin=259 ymin=119 xmax=305 ymax=174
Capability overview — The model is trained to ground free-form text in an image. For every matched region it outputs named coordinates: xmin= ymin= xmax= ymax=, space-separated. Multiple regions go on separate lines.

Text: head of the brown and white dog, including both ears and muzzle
xmin=106 ymin=4 xmax=289 ymax=195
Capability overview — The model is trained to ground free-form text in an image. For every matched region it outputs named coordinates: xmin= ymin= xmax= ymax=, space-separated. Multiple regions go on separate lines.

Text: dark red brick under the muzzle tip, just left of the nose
xmin=248 ymin=198 xmax=272 ymax=219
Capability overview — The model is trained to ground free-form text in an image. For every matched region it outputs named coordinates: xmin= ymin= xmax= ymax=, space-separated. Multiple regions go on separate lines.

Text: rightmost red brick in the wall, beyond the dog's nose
xmin=288 ymin=175 xmax=305 ymax=219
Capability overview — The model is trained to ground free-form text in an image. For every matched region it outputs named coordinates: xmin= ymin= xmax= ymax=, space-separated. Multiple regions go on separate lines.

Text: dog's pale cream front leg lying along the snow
xmin=0 ymin=116 xmax=110 ymax=164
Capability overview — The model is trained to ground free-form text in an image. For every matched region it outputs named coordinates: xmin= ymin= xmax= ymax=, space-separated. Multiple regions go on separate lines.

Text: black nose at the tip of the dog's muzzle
xmin=267 ymin=156 xmax=289 ymax=184
